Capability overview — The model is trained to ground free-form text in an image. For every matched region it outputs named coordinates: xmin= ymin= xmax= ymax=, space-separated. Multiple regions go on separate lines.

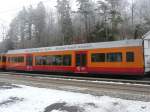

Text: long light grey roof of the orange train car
xmin=7 ymin=39 xmax=143 ymax=54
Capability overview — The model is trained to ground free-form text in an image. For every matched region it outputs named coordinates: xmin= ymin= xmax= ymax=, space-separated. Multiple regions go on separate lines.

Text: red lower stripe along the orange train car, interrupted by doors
xmin=6 ymin=66 xmax=144 ymax=75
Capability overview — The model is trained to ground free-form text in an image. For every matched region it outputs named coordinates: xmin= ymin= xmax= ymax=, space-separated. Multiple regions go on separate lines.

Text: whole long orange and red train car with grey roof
xmin=6 ymin=39 xmax=149 ymax=75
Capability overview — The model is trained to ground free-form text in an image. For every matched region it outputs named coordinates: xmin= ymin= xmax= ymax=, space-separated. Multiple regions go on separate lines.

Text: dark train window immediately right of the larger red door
xmin=91 ymin=53 xmax=105 ymax=62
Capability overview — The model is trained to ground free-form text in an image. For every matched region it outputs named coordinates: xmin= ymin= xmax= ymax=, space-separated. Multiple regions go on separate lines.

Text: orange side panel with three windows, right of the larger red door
xmin=88 ymin=46 xmax=144 ymax=75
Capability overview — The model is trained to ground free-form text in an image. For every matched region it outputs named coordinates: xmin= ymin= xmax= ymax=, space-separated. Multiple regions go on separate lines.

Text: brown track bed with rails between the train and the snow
xmin=0 ymin=72 xmax=150 ymax=101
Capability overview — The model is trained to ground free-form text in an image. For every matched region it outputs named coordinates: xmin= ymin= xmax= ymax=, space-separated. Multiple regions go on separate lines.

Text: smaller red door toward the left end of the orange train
xmin=26 ymin=54 xmax=33 ymax=71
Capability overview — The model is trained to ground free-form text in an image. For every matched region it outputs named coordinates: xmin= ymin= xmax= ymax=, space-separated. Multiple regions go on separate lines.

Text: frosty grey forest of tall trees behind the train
xmin=0 ymin=0 xmax=150 ymax=51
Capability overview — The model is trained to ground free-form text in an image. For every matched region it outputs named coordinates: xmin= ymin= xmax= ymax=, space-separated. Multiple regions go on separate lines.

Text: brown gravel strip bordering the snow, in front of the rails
xmin=0 ymin=75 xmax=150 ymax=102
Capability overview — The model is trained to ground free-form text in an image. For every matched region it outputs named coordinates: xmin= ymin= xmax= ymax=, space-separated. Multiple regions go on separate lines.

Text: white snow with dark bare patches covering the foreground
xmin=0 ymin=83 xmax=150 ymax=112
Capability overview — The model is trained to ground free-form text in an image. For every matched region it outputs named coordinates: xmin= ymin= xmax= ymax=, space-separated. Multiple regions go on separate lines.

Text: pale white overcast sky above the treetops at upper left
xmin=0 ymin=0 xmax=76 ymax=41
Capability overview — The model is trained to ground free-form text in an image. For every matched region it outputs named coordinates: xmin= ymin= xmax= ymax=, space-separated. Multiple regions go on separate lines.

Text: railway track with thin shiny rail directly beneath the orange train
xmin=0 ymin=72 xmax=150 ymax=85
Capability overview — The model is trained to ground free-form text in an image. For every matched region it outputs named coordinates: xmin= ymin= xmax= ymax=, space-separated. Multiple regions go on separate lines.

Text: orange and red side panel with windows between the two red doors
xmin=30 ymin=51 xmax=75 ymax=72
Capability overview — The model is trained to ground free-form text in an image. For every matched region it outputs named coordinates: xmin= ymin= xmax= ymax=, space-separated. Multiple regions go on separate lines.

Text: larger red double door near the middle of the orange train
xmin=75 ymin=51 xmax=87 ymax=73
